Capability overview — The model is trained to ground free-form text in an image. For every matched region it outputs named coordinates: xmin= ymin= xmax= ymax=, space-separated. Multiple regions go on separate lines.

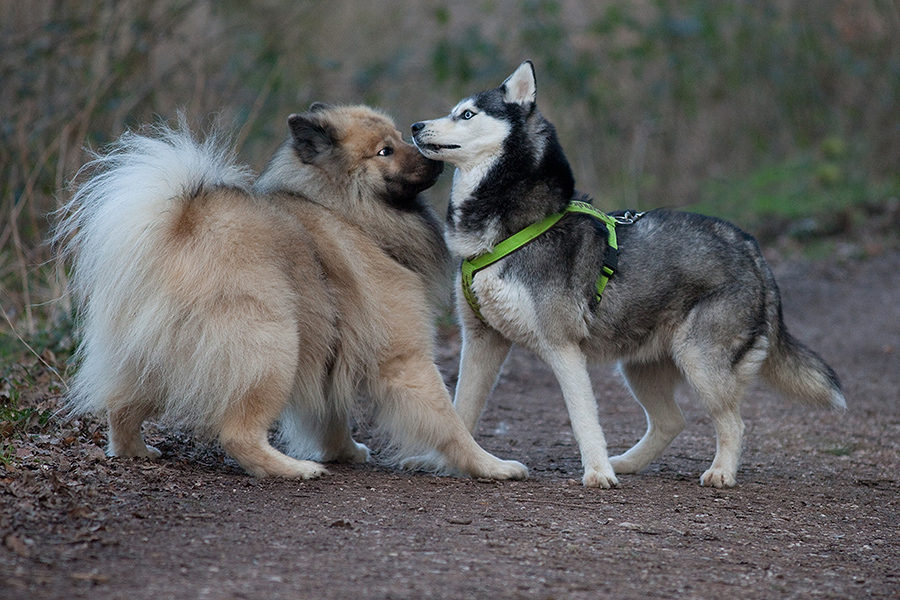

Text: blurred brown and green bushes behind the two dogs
xmin=0 ymin=0 xmax=900 ymax=359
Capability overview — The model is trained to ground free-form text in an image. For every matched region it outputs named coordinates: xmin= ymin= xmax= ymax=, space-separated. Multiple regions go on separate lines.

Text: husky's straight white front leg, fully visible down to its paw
xmin=544 ymin=346 xmax=619 ymax=489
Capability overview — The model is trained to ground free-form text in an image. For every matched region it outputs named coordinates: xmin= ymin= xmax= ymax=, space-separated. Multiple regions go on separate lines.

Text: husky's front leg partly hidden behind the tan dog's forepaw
xmin=453 ymin=324 xmax=512 ymax=433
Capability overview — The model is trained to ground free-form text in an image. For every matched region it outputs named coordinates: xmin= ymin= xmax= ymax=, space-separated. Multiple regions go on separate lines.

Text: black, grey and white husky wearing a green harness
xmin=412 ymin=62 xmax=846 ymax=488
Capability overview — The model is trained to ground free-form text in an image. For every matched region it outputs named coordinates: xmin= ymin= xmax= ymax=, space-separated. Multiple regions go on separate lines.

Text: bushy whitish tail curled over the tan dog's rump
xmin=52 ymin=117 xmax=252 ymax=424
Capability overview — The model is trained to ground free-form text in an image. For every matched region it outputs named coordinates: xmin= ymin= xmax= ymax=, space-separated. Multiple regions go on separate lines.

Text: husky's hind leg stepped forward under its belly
xmin=609 ymin=359 xmax=684 ymax=473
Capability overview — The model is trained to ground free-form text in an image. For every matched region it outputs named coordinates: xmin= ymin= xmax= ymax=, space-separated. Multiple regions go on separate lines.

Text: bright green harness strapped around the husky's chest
xmin=462 ymin=200 xmax=644 ymax=321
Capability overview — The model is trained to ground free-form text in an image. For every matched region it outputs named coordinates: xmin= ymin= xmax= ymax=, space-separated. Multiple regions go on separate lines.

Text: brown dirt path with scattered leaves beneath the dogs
xmin=0 ymin=249 xmax=900 ymax=600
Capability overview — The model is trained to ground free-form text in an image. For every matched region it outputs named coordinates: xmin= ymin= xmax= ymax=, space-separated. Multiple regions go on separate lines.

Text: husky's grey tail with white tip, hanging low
xmin=760 ymin=288 xmax=847 ymax=410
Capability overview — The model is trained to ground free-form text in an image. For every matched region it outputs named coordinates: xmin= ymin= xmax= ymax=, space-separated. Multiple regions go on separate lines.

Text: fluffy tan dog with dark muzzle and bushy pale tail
xmin=56 ymin=104 xmax=527 ymax=479
